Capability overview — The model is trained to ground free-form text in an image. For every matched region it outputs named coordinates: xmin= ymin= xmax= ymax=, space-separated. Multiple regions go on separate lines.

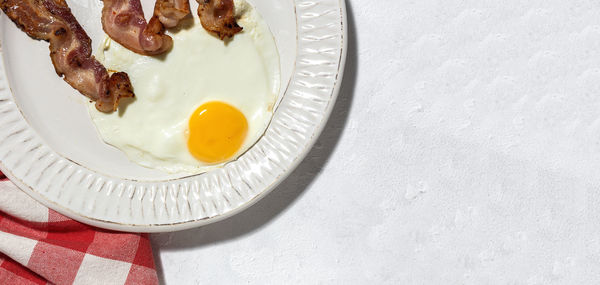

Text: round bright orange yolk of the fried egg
xmin=188 ymin=101 xmax=248 ymax=163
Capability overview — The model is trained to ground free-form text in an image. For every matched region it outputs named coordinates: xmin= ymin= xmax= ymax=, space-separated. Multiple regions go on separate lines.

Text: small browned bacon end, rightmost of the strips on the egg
xmin=196 ymin=0 xmax=242 ymax=39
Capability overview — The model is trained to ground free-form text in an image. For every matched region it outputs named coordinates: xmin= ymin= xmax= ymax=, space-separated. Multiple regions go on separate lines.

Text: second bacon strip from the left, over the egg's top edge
xmin=102 ymin=0 xmax=173 ymax=55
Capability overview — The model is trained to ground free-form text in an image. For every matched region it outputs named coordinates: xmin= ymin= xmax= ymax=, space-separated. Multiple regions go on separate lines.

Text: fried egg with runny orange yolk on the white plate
xmin=89 ymin=1 xmax=280 ymax=173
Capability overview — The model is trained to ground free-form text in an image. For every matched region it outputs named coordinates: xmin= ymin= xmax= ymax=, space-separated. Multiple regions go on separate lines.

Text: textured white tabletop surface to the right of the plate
xmin=152 ymin=0 xmax=600 ymax=284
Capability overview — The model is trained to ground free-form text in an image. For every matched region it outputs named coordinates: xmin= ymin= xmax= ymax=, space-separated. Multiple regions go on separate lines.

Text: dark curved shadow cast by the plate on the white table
xmin=155 ymin=1 xmax=358 ymax=283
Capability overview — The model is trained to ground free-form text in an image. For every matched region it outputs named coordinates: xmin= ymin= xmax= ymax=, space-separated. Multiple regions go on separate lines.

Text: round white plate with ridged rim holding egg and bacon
xmin=0 ymin=0 xmax=347 ymax=232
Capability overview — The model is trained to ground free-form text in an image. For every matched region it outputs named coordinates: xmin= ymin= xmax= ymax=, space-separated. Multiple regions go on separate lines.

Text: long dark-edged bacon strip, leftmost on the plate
xmin=0 ymin=0 xmax=134 ymax=113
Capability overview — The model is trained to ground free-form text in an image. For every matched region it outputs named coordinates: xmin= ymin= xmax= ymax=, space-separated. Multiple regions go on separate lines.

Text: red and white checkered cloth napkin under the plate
xmin=0 ymin=172 xmax=158 ymax=285
